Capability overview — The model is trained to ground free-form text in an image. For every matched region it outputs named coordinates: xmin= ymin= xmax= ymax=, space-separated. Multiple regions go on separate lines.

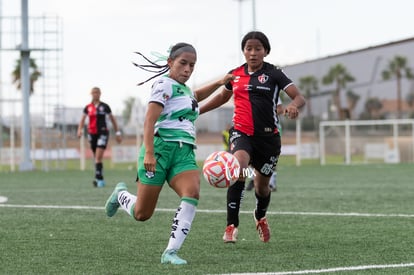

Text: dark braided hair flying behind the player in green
xmin=132 ymin=42 xmax=197 ymax=86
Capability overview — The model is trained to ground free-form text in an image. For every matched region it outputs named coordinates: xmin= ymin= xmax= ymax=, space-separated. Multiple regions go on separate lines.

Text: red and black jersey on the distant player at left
xmin=83 ymin=102 xmax=111 ymax=135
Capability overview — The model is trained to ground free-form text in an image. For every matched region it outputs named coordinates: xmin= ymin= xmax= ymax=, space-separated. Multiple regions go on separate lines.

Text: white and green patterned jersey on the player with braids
xmin=149 ymin=76 xmax=199 ymax=145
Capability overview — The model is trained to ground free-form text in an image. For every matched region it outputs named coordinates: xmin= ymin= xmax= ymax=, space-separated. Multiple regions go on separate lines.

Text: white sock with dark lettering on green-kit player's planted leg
xmin=166 ymin=199 xmax=198 ymax=253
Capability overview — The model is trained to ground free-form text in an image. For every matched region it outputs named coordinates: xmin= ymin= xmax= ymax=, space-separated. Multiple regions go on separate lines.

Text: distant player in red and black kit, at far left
xmin=78 ymin=87 xmax=122 ymax=187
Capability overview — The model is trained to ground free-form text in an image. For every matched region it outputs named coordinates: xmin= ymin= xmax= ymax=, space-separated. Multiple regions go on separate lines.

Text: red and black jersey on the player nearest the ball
xmin=225 ymin=62 xmax=293 ymax=135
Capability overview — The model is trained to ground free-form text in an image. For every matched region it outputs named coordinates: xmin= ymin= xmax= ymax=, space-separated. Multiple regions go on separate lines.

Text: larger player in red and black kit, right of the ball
xmin=200 ymin=31 xmax=305 ymax=243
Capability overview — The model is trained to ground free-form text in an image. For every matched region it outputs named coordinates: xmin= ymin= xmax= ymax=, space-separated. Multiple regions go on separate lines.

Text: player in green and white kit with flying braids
xmin=105 ymin=43 xmax=232 ymax=265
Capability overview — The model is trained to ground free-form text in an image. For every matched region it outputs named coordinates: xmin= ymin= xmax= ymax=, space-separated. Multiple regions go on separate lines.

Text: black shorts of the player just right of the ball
xmin=230 ymin=128 xmax=281 ymax=177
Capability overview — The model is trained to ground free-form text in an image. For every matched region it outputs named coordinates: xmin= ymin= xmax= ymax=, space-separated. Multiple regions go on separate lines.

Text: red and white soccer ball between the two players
xmin=203 ymin=151 xmax=240 ymax=188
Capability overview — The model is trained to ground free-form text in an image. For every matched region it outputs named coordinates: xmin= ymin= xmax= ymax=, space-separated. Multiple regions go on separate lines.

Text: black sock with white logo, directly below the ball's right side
xmin=227 ymin=181 xmax=244 ymax=227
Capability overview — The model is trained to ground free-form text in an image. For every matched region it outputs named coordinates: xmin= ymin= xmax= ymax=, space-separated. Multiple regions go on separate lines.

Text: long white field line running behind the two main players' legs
xmin=0 ymin=203 xmax=414 ymax=218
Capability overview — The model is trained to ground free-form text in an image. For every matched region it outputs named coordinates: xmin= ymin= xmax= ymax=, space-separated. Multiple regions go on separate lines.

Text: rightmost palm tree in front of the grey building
xmin=382 ymin=55 xmax=414 ymax=118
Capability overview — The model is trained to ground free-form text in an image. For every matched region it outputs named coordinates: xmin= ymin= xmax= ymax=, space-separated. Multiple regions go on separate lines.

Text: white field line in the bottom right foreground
xmin=215 ymin=263 xmax=414 ymax=275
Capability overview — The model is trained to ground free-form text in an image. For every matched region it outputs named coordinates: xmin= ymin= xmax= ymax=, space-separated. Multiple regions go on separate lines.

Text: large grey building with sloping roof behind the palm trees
xmin=283 ymin=38 xmax=414 ymax=120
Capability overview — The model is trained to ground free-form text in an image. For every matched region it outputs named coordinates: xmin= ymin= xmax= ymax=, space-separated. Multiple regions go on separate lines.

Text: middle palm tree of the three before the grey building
xmin=322 ymin=63 xmax=355 ymax=119
